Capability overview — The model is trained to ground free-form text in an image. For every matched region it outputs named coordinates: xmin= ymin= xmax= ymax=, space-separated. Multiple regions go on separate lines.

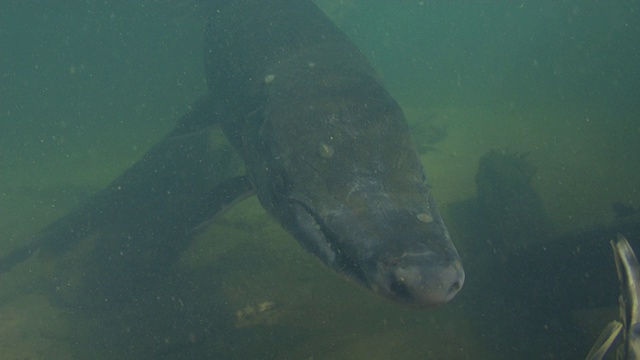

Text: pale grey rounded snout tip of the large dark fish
xmin=374 ymin=254 xmax=465 ymax=308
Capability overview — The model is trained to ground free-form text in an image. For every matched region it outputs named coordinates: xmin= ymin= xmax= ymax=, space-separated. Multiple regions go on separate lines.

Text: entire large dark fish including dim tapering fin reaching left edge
xmin=0 ymin=0 xmax=465 ymax=308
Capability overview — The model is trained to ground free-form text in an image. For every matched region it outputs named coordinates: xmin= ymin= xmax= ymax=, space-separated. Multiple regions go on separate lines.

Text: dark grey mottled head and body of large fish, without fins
xmin=205 ymin=0 xmax=464 ymax=307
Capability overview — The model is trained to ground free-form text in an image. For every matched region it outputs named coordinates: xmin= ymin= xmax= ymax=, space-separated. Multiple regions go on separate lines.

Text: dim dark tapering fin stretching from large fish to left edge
xmin=0 ymin=97 xmax=242 ymax=273
